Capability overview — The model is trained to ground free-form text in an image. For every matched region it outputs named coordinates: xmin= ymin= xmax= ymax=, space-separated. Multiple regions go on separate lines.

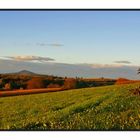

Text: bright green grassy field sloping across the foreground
xmin=0 ymin=83 xmax=140 ymax=130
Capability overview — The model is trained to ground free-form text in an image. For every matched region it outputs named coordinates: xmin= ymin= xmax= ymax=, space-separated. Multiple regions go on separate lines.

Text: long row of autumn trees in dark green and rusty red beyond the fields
xmin=0 ymin=76 xmax=115 ymax=90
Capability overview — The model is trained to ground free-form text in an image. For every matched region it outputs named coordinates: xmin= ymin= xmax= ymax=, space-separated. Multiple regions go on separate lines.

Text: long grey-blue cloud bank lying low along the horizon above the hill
xmin=0 ymin=60 xmax=140 ymax=80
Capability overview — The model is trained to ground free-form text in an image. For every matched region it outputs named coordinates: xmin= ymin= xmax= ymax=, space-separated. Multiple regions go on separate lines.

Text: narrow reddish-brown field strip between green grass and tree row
xmin=0 ymin=88 xmax=62 ymax=97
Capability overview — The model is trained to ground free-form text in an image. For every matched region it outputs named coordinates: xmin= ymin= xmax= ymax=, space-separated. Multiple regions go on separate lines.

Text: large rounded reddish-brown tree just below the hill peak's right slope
xmin=27 ymin=77 xmax=45 ymax=89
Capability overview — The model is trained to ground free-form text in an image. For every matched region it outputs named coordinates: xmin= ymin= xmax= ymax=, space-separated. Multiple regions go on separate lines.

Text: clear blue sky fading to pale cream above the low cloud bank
xmin=0 ymin=11 xmax=140 ymax=65
